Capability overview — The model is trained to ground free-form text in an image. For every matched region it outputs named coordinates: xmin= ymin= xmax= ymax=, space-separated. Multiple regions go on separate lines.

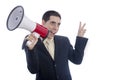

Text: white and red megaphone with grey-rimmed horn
xmin=7 ymin=6 xmax=49 ymax=38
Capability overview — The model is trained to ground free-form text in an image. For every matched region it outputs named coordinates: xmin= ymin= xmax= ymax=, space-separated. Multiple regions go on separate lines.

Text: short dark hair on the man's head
xmin=42 ymin=10 xmax=61 ymax=22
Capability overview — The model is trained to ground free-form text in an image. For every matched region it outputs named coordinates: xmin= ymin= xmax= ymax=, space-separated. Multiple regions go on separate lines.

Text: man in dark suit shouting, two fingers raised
xmin=23 ymin=10 xmax=88 ymax=80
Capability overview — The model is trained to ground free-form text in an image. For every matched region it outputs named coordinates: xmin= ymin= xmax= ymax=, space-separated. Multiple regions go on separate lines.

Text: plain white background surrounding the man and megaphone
xmin=0 ymin=0 xmax=120 ymax=80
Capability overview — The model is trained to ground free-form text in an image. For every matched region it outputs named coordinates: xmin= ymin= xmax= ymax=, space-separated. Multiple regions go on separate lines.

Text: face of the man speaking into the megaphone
xmin=42 ymin=16 xmax=61 ymax=38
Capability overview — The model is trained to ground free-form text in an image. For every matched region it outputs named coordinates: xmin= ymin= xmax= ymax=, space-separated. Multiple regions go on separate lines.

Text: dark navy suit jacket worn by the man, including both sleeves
xmin=24 ymin=36 xmax=88 ymax=80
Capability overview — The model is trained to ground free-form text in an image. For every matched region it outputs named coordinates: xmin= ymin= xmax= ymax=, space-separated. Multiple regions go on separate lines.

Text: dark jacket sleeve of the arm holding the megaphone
xmin=22 ymin=37 xmax=39 ymax=74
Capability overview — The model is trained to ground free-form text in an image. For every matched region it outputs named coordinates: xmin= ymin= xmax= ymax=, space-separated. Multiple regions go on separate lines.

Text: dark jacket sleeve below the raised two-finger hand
xmin=68 ymin=37 xmax=88 ymax=64
